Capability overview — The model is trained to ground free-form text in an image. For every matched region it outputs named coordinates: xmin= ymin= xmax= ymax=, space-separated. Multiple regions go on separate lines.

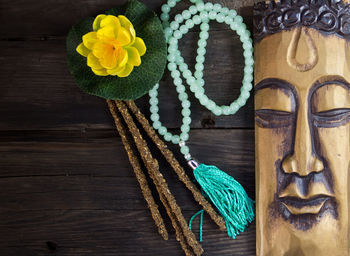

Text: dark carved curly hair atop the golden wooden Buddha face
xmin=253 ymin=0 xmax=350 ymax=42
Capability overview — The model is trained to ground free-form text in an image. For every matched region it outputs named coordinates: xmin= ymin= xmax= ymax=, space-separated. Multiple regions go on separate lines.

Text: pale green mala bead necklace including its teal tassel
xmin=149 ymin=0 xmax=254 ymax=238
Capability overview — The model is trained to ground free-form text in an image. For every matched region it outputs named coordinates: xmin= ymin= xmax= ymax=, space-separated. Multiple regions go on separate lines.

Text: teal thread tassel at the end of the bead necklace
xmin=193 ymin=164 xmax=255 ymax=239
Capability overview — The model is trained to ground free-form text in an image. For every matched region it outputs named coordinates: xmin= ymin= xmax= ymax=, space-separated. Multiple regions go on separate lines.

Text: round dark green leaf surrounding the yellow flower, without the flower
xmin=66 ymin=0 xmax=167 ymax=100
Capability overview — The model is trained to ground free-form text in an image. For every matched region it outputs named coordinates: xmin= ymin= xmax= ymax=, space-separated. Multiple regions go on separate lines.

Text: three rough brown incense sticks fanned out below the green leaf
xmin=107 ymin=100 xmax=226 ymax=255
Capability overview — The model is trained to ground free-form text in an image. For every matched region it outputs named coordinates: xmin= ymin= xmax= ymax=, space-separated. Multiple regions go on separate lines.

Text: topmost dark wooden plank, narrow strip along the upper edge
xmin=0 ymin=0 xmax=254 ymax=39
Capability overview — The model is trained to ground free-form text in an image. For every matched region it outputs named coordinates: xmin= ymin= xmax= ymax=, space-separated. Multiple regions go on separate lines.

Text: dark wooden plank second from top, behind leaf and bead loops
xmin=0 ymin=31 xmax=253 ymax=130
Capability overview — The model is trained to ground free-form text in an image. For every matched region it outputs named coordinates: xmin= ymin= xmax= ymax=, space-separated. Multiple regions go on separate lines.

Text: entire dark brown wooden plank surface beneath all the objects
xmin=0 ymin=0 xmax=255 ymax=256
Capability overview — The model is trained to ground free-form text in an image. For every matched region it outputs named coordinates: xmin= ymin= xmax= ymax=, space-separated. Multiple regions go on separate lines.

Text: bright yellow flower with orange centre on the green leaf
xmin=76 ymin=14 xmax=146 ymax=77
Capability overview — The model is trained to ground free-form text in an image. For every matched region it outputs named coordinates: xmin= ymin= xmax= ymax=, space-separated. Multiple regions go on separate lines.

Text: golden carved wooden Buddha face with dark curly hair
xmin=254 ymin=0 xmax=350 ymax=256
